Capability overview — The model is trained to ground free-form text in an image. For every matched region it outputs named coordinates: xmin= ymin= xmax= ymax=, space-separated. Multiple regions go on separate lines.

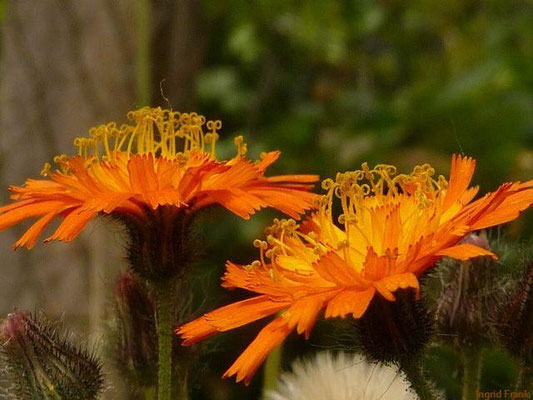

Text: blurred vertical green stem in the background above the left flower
xmin=136 ymin=0 xmax=151 ymax=107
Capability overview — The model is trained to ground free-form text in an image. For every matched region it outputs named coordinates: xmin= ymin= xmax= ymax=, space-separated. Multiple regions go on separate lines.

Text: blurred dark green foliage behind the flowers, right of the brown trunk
xmin=182 ymin=0 xmax=533 ymax=399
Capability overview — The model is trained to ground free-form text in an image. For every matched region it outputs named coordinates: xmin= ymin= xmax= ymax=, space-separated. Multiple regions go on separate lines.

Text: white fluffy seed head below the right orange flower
xmin=265 ymin=352 xmax=418 ymax=400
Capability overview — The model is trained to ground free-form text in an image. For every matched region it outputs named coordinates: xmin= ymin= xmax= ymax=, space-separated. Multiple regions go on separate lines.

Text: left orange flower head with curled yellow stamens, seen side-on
xmin=0 ymin=108 xmax=318 ymax=249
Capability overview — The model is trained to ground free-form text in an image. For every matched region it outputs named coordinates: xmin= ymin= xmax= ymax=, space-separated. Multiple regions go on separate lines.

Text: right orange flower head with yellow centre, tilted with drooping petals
xmin=177 ymin=156 xmax=533 ymax=383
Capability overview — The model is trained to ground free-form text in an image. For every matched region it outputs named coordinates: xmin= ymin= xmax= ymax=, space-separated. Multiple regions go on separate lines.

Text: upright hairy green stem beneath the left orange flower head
xmin=155 ymin=282 xmax=175 ymax=400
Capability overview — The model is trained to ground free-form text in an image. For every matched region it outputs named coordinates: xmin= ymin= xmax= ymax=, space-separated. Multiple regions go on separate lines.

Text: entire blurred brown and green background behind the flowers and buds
xmin=0 ymin=0 xmax=533 ymax=400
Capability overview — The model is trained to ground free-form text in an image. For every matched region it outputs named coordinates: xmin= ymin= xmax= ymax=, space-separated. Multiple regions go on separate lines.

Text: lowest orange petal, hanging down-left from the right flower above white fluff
xmin=223 ymin=317 xmax=291 ymax=385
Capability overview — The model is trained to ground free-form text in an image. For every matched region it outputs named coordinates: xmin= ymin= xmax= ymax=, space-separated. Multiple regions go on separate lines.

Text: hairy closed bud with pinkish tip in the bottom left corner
xmin=0 ymin=311 xmax=104 ymax=400
